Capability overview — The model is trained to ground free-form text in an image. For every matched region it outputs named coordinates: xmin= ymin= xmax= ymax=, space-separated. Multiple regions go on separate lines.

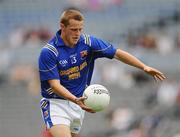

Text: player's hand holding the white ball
xmin=75 ymin=97 xmax=95 ymax=113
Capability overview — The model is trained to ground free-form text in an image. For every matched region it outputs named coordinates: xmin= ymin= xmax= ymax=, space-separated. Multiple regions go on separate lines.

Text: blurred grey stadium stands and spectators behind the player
xmin=0 ymin=0 xmax=180 ymax=137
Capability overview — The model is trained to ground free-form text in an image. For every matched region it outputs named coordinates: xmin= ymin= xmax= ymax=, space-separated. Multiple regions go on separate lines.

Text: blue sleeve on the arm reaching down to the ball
xmin=38 ymin=48 xmax=59 ymax=81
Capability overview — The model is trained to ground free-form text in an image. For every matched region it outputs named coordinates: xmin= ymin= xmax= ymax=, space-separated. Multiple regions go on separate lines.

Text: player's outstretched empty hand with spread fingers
xmin=144 ymin=66 xmax=166 ymax=81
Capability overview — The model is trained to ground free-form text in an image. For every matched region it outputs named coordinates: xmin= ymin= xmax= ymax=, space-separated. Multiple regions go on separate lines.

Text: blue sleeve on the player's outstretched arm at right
xmin=90 ymin=36 xmax=116 ymax=59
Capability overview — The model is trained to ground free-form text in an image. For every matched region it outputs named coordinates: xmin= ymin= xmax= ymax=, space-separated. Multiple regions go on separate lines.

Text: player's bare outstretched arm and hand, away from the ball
xmin=114 ymin=49 xmax=166 ymax=81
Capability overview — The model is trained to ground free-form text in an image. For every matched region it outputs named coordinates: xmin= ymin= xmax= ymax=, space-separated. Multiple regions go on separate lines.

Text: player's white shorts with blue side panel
xmin=40 ymin=98 xmax=85 ymax=134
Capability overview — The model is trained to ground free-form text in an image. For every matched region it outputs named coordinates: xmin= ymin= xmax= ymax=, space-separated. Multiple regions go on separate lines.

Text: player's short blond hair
xmin=60 ymin=9 xmax=84 ymax=26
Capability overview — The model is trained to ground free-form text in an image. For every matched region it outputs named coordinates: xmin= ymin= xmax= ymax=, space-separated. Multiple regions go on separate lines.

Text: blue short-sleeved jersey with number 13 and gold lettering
xmin=39 ymin=31 xmax=116 ymax=99
